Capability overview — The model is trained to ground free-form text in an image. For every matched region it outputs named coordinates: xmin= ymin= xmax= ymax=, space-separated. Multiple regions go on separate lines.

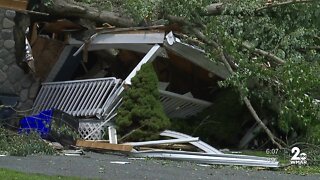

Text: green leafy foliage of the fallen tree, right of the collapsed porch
xmin=121 ymin=0 xmax=320 ymax=143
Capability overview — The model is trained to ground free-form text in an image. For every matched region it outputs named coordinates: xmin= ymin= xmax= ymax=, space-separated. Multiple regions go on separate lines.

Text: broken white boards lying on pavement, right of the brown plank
xmin=124 ymin=130 xmax=279 ymax=167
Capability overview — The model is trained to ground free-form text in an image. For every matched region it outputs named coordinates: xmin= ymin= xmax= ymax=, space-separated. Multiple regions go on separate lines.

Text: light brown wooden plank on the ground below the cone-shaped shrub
xmin=76 ymin=140 xmax=132 ymax=152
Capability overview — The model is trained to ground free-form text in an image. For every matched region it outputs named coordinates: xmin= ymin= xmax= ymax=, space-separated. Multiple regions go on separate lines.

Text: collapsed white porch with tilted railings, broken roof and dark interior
xmin=33 ymin=28 xmax=228 ymax=139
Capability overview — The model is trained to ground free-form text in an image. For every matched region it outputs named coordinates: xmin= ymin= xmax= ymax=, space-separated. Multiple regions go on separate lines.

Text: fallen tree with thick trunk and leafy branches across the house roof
xmin=28 ymin=0 xmax=320 ymax=147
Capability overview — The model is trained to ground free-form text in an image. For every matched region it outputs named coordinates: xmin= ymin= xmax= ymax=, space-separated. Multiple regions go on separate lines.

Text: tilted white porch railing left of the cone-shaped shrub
xmin=33 ymin=78 xmax=121 ymax=117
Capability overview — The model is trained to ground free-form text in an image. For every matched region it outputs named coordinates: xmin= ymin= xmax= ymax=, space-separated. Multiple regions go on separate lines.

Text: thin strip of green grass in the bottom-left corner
xmin=0 ymin=168 xmax=80 ymax=180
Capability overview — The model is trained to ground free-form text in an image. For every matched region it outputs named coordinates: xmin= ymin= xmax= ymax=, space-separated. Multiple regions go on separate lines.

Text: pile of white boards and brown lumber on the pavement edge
xmin=77 ymin=130 xmax=279 ymax=167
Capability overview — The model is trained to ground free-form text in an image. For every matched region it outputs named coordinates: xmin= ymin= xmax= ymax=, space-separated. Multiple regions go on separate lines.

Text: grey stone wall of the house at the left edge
xmin=0 ymin=9 xmax=40 ymax=110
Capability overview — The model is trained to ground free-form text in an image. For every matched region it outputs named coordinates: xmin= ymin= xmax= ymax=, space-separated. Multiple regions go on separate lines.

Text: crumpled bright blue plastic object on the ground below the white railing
xmin=19 ymin=109 xmax=53 ymax=138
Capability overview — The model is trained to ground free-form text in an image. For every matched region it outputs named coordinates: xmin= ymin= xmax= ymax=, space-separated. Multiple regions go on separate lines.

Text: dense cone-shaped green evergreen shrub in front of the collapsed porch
xmin=116 ymin=64 xmax=170 ymax=141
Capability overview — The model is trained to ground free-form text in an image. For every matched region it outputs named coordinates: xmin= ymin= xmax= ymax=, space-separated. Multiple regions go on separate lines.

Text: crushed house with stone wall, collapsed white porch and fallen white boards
xmin=0 ymin=1 xmax=284 ymax=167
